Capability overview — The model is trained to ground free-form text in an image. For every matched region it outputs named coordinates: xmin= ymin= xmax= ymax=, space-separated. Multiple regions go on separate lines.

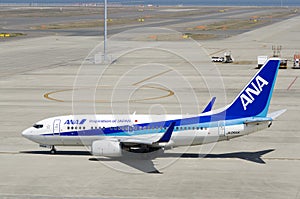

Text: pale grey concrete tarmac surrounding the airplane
xmin=0 ymin=7 xmax=300 ymax=199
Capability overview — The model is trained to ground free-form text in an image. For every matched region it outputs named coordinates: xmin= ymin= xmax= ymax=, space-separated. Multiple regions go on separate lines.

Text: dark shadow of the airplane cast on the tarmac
xmin=20 ymin=149 xmax=275 ymax=173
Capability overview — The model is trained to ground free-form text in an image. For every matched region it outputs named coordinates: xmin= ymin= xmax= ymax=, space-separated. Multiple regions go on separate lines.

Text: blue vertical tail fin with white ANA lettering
xmin=225 ymin=58 xmax=280 ymax=119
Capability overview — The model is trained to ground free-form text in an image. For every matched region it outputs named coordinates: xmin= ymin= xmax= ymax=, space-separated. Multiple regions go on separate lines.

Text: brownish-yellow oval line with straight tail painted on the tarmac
xmin=44 ymin=69 xmax=175 ymax=103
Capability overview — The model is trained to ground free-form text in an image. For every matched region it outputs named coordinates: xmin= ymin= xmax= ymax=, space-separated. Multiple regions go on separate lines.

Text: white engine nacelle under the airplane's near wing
xmin=92 ymin=140 xmax=122 ymax=157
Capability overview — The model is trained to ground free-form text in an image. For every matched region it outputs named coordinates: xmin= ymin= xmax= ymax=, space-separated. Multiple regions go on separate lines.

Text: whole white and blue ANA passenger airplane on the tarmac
xmin=22 ymin=58 xmax=285 ymax=157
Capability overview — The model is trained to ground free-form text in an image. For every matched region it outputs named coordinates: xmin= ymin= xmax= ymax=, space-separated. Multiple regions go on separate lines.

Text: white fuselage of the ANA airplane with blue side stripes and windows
xmin=23 ymin=115 xmax=270 ymax=147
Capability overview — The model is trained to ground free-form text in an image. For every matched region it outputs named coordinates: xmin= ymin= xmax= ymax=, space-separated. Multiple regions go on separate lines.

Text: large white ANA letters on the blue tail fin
xmin=240 ymin=75 xmax=269 ymax=110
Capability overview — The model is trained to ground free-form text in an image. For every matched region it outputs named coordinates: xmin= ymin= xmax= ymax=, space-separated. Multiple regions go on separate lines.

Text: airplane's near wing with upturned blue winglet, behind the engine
xmin=120 ymin=122 xmax=175 ymax=147
